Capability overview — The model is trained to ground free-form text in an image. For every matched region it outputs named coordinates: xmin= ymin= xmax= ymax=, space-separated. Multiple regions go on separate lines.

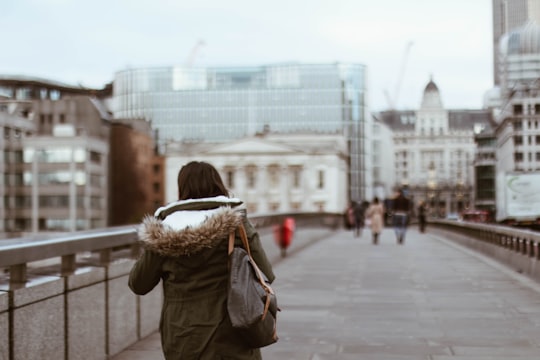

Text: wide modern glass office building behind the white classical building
xmin=113 ymin=63 xmax=370 ymax=200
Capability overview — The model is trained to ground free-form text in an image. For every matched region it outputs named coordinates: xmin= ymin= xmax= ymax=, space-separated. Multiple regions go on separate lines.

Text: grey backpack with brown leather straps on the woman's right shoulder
xmin=227 ymin=225 xmax=279 ymax=348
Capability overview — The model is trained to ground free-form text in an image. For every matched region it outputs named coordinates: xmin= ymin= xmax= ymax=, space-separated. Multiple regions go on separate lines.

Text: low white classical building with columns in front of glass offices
xmin=165 ymin=133 xmax=348 ymax=214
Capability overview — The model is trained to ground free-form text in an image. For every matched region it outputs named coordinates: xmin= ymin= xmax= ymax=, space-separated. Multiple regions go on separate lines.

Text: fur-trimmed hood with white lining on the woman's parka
xmin=138 ymin=196 xmax=245 ymax=257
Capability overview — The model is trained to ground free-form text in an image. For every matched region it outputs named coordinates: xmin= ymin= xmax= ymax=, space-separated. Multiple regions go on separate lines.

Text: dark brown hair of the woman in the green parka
xmin=178 ymin=161 xmax=229 ymax=200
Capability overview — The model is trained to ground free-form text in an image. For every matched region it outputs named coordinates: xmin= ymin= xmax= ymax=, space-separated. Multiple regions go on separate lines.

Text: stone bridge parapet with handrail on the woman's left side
xmin=0 ymin=213 xmax=342 ymax=360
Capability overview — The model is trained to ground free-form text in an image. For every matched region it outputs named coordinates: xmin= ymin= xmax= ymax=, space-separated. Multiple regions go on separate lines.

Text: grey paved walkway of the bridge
xmin=113 ymin=227 xmax=540 ymax=360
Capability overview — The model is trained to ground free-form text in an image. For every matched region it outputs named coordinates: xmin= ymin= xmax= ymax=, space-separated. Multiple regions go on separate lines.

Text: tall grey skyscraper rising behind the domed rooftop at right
xmin=492 ymin=0 xmax=540 ymax=85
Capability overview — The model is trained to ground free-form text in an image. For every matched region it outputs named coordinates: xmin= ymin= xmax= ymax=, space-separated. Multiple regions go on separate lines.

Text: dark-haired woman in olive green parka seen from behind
xmin=129 ymin=162 xmax=274 ymax=360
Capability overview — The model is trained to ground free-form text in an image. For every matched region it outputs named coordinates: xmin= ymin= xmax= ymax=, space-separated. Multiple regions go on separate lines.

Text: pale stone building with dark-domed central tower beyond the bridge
xmin=377 ymin=80 xmax=492 ymax=217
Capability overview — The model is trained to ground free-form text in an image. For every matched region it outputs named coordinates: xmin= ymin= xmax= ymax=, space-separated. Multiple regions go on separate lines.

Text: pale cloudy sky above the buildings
xmin=0 ymin=0 xmax=493 ymax=111
